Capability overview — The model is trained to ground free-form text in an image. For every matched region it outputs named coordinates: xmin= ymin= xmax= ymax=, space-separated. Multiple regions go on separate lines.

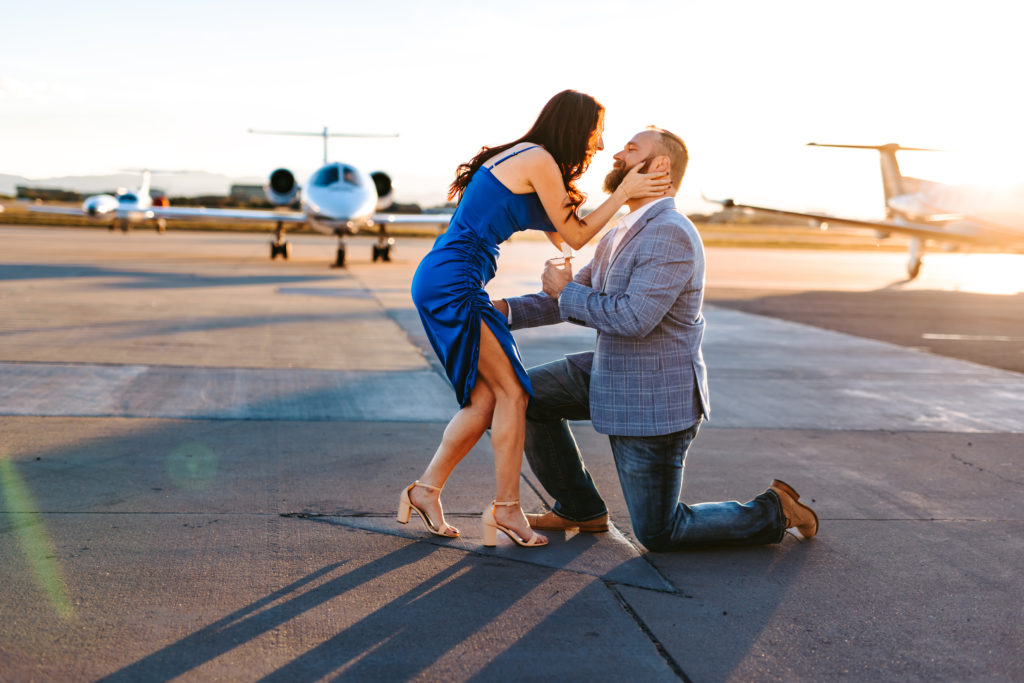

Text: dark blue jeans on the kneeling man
xmin=526 ymin=358 xmax=785 ymax=551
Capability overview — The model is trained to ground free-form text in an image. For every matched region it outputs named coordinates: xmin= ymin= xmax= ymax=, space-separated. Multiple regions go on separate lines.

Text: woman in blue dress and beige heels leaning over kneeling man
xmin=398 ymin=90 xmax=669 ymax=547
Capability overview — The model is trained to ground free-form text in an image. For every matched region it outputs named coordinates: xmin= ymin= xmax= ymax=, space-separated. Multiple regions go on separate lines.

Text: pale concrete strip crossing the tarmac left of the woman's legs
xmin=0 ymin=362 xmax=458 ymax=422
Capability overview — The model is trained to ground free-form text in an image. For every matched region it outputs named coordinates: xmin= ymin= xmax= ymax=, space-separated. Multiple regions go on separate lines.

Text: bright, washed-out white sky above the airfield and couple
xmin=0 ymin=0 xmax=1024 ymax=215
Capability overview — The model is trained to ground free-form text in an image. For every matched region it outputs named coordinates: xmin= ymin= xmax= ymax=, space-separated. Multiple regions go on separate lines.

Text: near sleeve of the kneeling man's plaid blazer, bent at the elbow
xmin=558 ymin=223 xmax=696 ymax=339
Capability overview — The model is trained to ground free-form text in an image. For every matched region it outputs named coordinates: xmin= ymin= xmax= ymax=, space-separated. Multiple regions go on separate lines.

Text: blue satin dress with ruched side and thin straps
xmin=413 ymin=145 xmax=555 ymax=407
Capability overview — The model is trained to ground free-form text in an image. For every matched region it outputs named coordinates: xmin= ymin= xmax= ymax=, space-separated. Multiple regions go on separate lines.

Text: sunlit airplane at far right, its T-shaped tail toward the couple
xmin=713 ymin=142 xmax=1024 ymax=280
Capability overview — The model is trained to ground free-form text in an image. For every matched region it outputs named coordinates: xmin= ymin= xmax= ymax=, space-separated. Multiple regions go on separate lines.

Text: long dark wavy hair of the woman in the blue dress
xmin=449 ymin=90 xmax=604 ymax=216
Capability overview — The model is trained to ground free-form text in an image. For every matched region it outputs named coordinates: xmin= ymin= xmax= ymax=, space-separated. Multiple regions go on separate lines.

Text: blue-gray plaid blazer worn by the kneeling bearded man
xmin=508 ymin=200 xmax=711 ymax=436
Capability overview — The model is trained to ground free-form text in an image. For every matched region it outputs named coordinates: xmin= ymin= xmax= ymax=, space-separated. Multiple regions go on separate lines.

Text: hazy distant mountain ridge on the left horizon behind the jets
xmin=0 ymin=171 xmax=265 ymax=197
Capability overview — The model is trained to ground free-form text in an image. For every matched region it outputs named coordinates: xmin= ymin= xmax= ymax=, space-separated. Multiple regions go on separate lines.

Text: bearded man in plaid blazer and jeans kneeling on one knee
xmin=495 ymin=127 xmax=818 ymax=551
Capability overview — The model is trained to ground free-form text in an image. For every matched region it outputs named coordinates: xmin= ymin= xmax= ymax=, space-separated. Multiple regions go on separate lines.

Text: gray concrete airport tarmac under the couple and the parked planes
xmin=0 ymin=227 xmax=1024 ymax=681
